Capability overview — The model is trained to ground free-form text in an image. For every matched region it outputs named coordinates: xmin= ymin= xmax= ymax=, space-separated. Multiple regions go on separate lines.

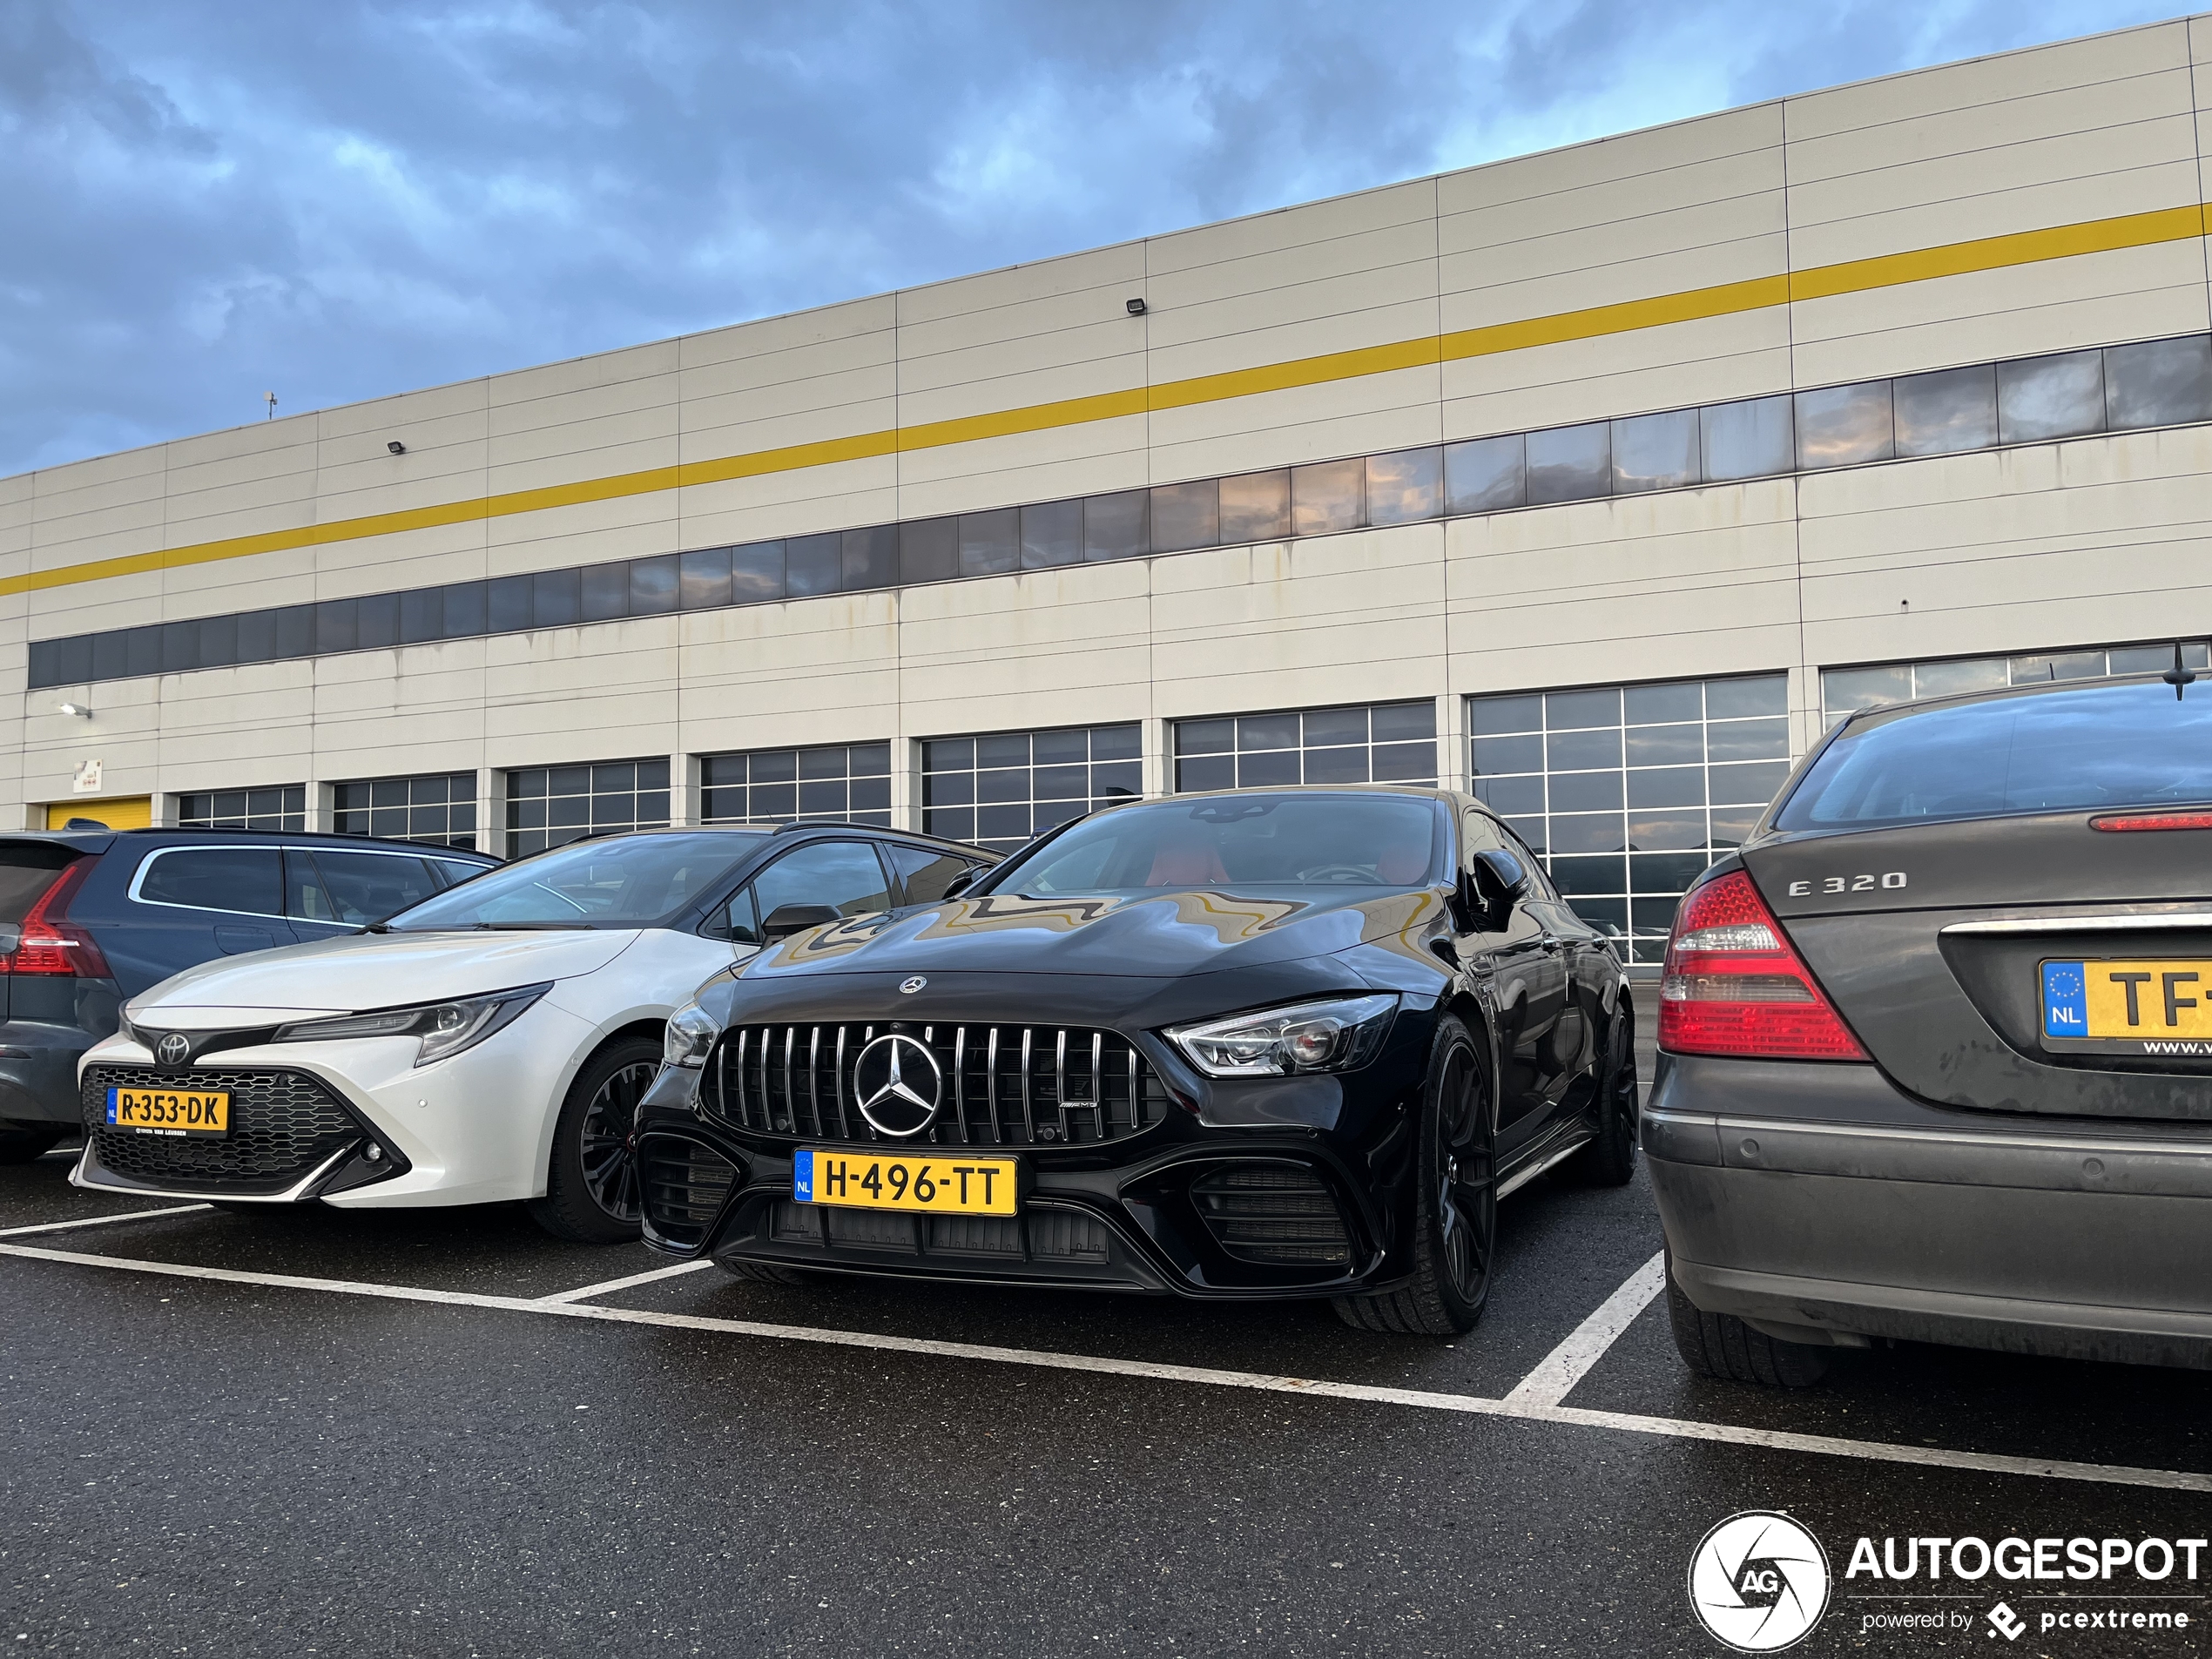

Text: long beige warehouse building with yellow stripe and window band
xmin=0 ymin=17 xmax=2212 ymax=962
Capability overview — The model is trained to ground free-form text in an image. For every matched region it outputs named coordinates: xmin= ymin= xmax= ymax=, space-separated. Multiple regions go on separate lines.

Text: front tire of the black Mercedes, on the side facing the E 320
xmin=1336 ymin=1015 xmax=1498 ymax=1336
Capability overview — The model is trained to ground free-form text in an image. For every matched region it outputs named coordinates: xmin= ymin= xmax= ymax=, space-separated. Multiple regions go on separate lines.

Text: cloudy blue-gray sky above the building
xmin=0 ymin=0 xmax=2175 ymax=475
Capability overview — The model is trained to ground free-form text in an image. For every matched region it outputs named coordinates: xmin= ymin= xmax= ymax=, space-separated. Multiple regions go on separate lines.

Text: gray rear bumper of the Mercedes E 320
xmin=1643 ymin=1055 xmax=2212 ymax=1369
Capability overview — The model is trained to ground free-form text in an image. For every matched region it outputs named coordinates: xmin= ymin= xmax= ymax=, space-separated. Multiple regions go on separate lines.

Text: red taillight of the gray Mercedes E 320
xmin=1659 ymin=869 xmax=1867 ymax=1060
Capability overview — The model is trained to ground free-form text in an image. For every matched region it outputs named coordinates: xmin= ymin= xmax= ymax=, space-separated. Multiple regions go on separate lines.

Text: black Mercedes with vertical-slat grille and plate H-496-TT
xmin=637 ymin=786 xmax=1637 ymax=1336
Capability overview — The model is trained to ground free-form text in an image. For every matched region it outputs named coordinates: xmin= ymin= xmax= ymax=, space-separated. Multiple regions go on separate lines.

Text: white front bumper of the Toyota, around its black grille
xmin=71 ymin=1000 xmax=593 ymax=1208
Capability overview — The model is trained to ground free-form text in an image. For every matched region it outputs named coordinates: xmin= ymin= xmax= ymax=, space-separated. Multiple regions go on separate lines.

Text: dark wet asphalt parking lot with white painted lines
xmin=0 ymin=1066 xmax=2212 ymax=1655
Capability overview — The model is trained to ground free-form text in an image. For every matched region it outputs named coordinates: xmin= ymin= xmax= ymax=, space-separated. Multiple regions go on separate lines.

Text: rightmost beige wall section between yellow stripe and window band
xmin=1790 ymin=239 xmax=2208 ymax=388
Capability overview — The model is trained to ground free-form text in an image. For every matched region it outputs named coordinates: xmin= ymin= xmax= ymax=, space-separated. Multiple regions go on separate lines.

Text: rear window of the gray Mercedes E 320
xmin=1774 ymin=681 xmax=2212 ymax=830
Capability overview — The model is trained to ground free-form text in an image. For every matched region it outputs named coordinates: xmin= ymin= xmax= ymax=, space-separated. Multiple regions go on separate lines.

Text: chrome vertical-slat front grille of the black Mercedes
xmin=699 ymin=1024 xmax=1168 ymax=1146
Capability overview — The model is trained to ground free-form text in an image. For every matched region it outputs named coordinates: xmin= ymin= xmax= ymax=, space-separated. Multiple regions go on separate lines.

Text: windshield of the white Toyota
xmin=389 ymin=830 xmax=765 ymax=934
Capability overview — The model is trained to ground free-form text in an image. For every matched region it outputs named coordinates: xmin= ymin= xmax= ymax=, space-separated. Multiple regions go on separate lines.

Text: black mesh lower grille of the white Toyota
xmin=84 ymin=1066 xmax=375 ymax=1195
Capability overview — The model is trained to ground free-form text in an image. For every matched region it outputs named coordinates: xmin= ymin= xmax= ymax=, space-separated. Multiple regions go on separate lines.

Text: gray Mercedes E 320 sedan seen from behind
xmin=1642 ymin=655 xmax=2212 ymax=1387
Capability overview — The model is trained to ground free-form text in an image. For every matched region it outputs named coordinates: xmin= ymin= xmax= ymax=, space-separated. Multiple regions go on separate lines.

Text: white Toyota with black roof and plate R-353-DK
xmin=71 ymin=823 xmax=991 ymax=1243
